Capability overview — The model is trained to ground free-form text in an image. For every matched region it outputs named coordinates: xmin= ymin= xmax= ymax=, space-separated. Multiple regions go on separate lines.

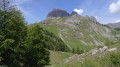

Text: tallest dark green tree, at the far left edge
xmin=0 ymin=0 xmax=27 ymax=67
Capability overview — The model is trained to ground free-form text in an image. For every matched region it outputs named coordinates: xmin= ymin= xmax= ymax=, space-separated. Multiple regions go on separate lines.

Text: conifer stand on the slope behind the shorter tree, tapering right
xmin=45 ymin=30 xmax=69 ymax=51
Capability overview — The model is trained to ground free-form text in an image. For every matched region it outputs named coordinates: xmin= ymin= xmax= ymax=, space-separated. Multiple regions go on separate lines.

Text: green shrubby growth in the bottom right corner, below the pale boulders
xmin=83 ymin=51 xmax=120 ymax=67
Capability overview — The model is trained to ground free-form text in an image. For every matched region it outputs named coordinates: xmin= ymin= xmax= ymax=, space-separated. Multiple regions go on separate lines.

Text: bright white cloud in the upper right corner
xmin=109 ymin=0 xmax=120 ymax=13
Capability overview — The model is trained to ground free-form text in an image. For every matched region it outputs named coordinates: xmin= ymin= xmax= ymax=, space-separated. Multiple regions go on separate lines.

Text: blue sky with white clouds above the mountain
xmin=11 ymin=0 xmax=120 ymax=24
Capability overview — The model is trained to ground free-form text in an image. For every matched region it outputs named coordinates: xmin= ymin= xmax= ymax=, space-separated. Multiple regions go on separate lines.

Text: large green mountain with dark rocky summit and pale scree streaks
xmin=39 ymin=9 xmax=115 ymax=50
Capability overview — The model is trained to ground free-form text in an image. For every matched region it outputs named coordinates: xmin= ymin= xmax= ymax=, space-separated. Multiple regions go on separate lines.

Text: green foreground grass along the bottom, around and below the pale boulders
xmin=47 ymin=43 xmax=120 ymax=67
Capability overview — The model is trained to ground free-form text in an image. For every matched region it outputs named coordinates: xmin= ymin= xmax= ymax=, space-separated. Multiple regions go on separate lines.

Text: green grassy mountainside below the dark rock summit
xmin=39 ymin=18 xmax=112 ymax=51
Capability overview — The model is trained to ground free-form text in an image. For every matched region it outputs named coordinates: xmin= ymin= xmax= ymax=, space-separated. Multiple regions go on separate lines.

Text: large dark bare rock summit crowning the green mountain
xmin=47 ymin=8 xmax=70 ymax=17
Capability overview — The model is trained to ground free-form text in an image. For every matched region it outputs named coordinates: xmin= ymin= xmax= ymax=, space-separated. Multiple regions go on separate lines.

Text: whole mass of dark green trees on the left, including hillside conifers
xmin=0 ymin=0 xmax=62 ymax=67
